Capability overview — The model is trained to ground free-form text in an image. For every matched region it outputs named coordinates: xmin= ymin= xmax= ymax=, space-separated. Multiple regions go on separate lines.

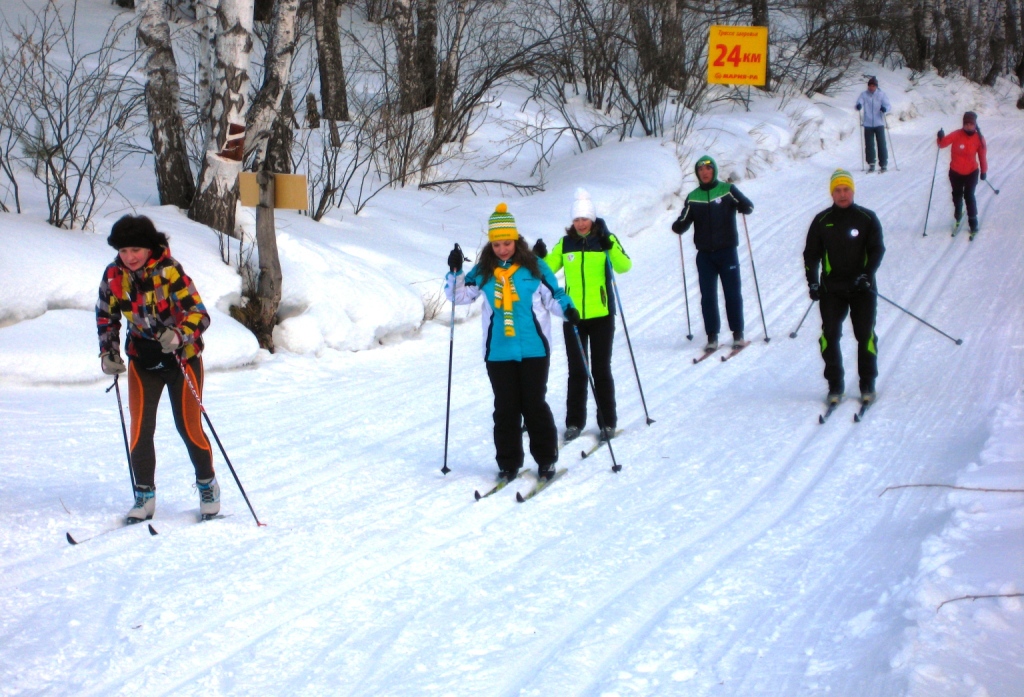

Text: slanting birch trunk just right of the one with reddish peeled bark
xmin=245 ymin=0 xmax=299 ymax=165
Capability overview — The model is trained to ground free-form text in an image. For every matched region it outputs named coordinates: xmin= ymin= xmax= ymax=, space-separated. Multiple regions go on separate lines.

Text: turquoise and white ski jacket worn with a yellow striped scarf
xmin=444 ymin=259 xmax=573 ymax=361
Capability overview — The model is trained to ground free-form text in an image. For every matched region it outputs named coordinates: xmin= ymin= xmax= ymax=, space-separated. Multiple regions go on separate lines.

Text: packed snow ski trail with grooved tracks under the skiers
xmin=0 ymin=119 xmax=1024 ymax=695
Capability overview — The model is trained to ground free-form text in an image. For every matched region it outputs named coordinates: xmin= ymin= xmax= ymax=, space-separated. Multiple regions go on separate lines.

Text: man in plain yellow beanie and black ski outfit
xmin=804 ymin=169 xmax=886 ymax=405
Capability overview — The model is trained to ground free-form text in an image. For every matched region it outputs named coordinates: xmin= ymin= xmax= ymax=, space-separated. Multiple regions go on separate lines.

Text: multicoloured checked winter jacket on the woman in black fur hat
xmin=96 ymin=248 xmax=210 ymax=359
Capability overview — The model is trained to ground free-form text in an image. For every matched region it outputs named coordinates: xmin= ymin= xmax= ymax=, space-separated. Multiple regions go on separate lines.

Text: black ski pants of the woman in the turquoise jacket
xmin=487 ymin=356 xmax=558 ymax=479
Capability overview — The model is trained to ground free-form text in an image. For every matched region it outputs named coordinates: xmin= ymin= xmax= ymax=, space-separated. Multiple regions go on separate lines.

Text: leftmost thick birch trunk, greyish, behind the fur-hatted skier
xmin=136 ymin=0 xmax=196 ymax=208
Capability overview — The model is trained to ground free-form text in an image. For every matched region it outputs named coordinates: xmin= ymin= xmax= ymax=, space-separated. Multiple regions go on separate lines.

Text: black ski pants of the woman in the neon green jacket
xmin=562 ymin=314 xmax=618 ymax=429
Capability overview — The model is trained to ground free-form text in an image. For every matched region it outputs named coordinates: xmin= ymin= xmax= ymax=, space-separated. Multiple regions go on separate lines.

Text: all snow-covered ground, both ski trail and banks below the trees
xmin=0 ymin=2 xmax=1024 ymax=697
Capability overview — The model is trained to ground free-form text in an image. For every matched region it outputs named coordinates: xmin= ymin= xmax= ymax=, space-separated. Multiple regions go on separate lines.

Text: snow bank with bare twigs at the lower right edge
xmin=893 ymin=392 xmax=1024 ymax=697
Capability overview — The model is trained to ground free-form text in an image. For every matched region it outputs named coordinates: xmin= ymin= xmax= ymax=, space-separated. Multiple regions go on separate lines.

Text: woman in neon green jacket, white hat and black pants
xmin=534 ymin=188 xmax=633 ymax=441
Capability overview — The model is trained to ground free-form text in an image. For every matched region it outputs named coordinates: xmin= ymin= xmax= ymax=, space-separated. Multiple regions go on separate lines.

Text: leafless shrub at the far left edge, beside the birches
xmin=0 ymin=0 xmax=144 ymax=228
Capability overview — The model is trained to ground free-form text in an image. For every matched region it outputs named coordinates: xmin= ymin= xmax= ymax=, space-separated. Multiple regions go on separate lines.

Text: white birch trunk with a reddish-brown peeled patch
xmin=188 ymin=0 xmax=253 ymax=236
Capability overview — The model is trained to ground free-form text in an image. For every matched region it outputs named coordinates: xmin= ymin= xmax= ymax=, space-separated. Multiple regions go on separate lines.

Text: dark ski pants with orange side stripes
xmin=128 ymin=356 xmax=213 ymax=488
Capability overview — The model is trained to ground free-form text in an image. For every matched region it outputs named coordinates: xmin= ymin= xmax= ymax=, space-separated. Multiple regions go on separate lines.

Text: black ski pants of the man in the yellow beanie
xmin=818 ymin=291 xmax=879 ymax=392
